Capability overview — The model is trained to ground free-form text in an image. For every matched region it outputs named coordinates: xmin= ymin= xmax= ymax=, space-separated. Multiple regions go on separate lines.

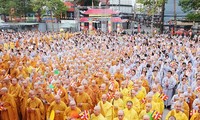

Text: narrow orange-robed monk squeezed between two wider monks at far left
xmin=20 ymin=78 xmax=30 ymax=120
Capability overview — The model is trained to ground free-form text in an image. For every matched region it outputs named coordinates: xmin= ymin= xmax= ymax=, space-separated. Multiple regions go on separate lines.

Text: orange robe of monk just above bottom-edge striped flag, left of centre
xmin=75 ymin=93 xmax=92 ymax=111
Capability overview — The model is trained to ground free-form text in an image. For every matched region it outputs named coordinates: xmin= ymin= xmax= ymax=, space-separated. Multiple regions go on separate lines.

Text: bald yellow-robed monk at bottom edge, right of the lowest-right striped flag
xmin=165 ymin=101 xmax=188 ymax=120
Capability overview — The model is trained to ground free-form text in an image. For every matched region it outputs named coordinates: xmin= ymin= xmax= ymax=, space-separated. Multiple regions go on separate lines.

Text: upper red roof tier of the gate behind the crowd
xmin=83 ymin=9 xmax=119 ymax=16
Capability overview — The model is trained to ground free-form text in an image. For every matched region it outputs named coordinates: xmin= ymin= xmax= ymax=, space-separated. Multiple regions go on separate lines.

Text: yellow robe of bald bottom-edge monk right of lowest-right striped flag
xmin=165 ymin=110 xmax=188 ymax=120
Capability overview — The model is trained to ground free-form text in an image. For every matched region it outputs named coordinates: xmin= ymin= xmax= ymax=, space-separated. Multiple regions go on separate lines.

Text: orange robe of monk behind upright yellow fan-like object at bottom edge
xmin=47 ymin=101 xmax=67 ymax=120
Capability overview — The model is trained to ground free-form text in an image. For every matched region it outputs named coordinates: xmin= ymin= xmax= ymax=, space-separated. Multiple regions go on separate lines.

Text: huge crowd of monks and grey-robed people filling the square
xmin=0 ymin=31 xmax=200 ymax=120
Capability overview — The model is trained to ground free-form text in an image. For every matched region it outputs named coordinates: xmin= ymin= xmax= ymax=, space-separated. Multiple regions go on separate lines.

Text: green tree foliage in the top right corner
xmin=179 ymin=0 xmax=200 ymax=21
